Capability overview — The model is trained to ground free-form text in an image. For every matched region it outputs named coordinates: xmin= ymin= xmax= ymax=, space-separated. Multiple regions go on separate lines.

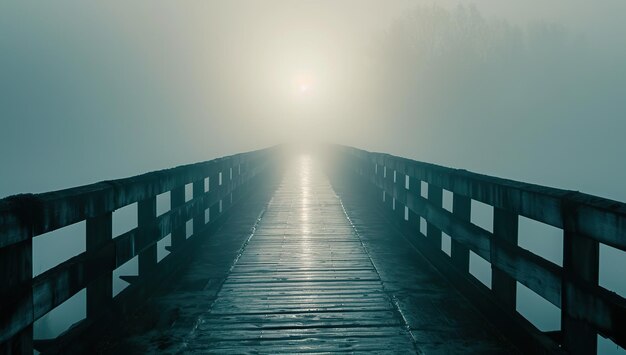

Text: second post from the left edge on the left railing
xmin=86 ymin=212 xmax=113 ymax=318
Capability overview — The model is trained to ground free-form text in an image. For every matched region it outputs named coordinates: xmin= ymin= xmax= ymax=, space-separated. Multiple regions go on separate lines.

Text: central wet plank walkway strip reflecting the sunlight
xmin=184 ymin=159 xmax=416 ymax=354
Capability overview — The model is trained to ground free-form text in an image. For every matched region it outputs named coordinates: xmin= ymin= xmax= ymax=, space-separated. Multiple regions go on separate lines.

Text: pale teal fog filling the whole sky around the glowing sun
xmin=0 ymin=0 xmax=626 ymax=354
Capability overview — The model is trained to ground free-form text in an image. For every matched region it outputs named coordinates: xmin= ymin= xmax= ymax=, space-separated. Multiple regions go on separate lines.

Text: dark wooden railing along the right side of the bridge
xmin=331 ymin=146 xmax=626 ymax=354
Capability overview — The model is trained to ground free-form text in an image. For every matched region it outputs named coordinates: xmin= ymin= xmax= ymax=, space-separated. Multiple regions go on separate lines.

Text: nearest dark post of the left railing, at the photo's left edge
xmin=0 ymin=239 xmax=33 ymax=354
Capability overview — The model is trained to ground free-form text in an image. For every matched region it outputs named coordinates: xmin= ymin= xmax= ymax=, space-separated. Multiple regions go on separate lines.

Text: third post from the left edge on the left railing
xmin=137 ymin=196 xmax=157 ymax=277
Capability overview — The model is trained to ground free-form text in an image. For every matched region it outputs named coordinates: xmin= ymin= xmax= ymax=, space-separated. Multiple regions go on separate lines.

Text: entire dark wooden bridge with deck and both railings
xmin=0 ymin=146 xmax=626 ymax=354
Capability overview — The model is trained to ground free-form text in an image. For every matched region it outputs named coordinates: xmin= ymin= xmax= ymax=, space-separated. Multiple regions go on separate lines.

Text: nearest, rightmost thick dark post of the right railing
xmin=561 ymin=208 xmax=600 ymax=354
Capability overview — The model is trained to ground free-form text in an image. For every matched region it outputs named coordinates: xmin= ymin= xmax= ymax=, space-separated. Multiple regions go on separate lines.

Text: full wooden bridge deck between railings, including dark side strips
xmin=90 ymin=159 xmax=515 ymax=354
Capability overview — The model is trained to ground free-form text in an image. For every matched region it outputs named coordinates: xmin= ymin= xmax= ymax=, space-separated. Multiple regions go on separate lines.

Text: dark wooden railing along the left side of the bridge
xmin=0 ymin=148 xmax=277 ymax=353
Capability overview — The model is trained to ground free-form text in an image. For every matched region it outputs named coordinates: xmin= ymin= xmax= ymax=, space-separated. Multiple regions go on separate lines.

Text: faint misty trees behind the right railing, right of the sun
xmin=354 ymin=6 xmax=626 ymax=199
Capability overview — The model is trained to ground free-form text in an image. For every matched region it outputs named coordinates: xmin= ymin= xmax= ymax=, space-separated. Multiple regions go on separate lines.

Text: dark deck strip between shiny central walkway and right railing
xmin=330 ymin=165 xmax=516 ymax=354
